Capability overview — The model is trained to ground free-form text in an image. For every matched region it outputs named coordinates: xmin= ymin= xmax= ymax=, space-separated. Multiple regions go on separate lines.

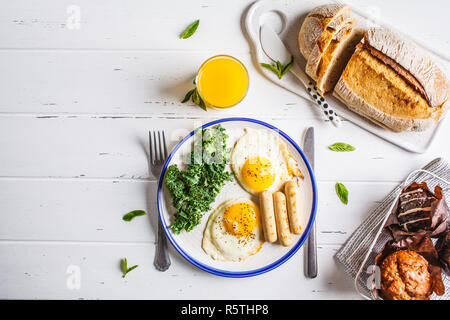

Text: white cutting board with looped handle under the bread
xmin=245 ymin=0 xmax=450 ymax=153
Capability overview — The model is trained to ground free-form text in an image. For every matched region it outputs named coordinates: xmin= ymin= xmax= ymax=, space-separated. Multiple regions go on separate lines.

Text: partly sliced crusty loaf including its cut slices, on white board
xmin=298 ymin=4 xmax=450 ymax=132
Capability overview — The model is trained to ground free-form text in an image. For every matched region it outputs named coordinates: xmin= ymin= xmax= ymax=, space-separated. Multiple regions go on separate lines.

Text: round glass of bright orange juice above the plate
xmin=195 ymin=55 xmax=249 ymax=108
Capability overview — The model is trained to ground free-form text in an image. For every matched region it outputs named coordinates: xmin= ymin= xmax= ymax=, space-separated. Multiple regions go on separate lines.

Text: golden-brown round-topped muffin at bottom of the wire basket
xmin=380 ymin=250 xmax=433 ymax=300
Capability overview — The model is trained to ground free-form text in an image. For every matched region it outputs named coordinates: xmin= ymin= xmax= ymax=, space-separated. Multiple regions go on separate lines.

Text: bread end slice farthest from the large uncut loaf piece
xmin=298 ymin=4 xmax=351 ymax=60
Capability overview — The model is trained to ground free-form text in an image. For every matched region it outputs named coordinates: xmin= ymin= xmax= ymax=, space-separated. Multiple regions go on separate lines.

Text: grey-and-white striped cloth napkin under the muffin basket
xmin=335 ymin=158 xmax=450 ymax=300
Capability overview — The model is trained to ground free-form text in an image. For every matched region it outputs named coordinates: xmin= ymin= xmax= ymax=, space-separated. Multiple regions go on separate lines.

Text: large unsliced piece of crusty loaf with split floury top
xmin=333 ymin=28 xmax=450 ymax=132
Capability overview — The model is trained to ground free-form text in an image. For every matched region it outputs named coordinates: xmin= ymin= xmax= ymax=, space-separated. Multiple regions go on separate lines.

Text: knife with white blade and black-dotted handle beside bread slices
xmin=259 ymin=23 xmax=341 ymax=126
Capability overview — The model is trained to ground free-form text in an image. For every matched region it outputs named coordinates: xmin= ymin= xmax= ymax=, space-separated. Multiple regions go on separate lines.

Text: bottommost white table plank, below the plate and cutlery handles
xmin=0 ymin=241 xmax=355 ymax=300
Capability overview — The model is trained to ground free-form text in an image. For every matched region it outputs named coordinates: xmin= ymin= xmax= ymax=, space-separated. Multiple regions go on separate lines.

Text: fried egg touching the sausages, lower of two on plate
xmin=202 ymin=198 xmax=264 ymax=261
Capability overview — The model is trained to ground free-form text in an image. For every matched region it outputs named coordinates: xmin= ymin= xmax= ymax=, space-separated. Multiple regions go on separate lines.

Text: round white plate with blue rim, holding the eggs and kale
xmin=157 ymin=118 xmax=317 ymax=278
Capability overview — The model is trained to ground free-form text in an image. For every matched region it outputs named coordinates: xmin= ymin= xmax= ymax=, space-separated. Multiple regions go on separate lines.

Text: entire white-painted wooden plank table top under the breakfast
xmin=0 ymin=0 xmax=450 ymax=299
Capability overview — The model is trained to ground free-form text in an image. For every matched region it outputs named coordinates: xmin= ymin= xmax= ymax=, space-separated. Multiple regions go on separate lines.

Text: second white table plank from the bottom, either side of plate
xmin=0 ymin=178 xmax=395 ymax=245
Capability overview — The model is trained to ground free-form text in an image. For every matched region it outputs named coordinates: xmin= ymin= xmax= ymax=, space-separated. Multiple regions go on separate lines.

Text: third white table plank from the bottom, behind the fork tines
xmin=0 ymin=112 xmax=450 ymax=181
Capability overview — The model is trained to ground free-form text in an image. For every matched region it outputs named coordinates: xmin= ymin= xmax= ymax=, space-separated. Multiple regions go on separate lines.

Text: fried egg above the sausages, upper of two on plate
xmin=230 ymin=128 xmax=302 ymax=195
